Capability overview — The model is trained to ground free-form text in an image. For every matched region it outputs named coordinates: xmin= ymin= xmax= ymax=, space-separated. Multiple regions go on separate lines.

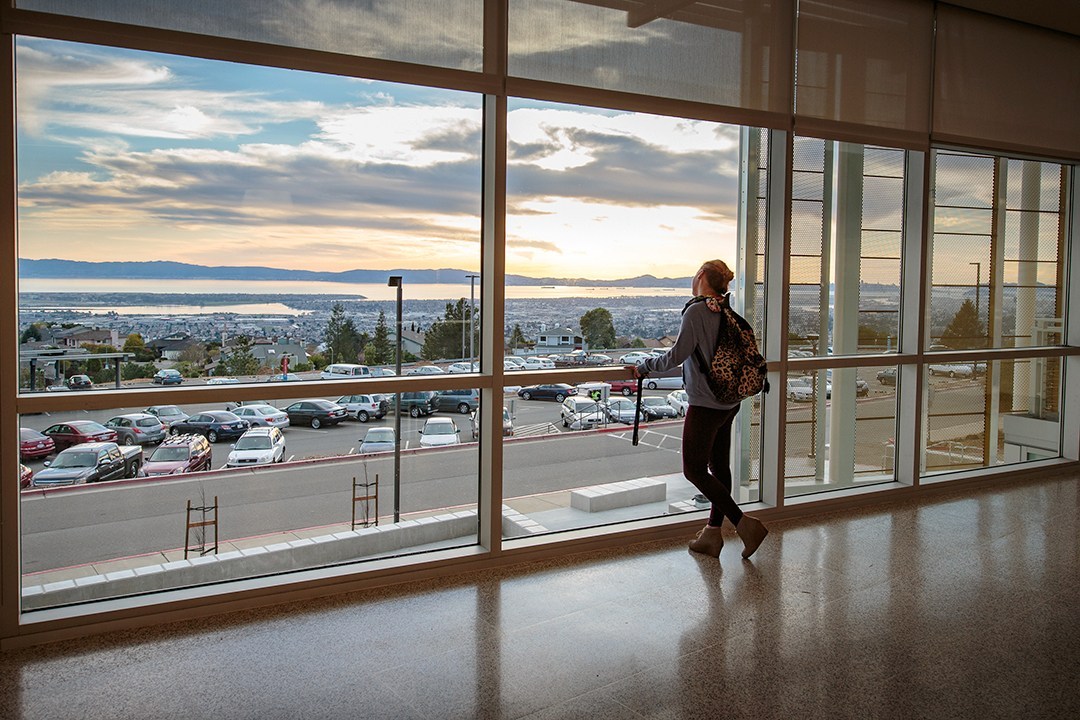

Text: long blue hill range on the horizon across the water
xmin=18 ymin=258 xmax=690 ymax=287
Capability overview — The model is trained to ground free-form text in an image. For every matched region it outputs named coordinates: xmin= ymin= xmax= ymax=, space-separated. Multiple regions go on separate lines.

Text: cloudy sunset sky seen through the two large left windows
xmin=16 ymin=39 xmax=738 ymax=279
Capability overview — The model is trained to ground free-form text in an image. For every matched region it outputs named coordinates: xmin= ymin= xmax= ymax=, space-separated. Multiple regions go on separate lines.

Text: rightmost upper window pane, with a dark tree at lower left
xmin=927 ymin=150 xmax=1067 ymax=351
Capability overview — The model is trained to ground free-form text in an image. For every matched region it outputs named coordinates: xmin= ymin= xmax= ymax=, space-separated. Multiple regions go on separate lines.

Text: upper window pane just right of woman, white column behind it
xmin=787 ymin=137 xmax=905 ymax=357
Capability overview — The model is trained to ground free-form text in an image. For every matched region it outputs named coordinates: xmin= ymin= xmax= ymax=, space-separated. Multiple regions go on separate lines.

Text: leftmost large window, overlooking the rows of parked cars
xmin=17 ymin=39 xmax=482 ymax=607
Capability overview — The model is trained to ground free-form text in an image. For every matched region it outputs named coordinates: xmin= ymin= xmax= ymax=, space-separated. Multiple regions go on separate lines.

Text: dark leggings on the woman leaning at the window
xmin=683 ymin=405 xmax=742 ymax=528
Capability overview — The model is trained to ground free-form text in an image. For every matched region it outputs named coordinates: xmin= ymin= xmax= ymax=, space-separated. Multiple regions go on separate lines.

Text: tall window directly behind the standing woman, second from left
xmin=503 ymin=100 xmax=768 ymax=534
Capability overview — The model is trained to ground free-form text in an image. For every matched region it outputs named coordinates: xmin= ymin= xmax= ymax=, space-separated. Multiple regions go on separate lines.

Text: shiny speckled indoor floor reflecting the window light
xmin=0 ymin=476 xmax=1080 ymax=720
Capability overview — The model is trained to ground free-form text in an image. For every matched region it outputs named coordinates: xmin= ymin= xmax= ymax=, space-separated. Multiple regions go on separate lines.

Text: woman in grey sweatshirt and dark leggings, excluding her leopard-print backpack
xmin=626 ymin=260 xmax=769 ymax=558
